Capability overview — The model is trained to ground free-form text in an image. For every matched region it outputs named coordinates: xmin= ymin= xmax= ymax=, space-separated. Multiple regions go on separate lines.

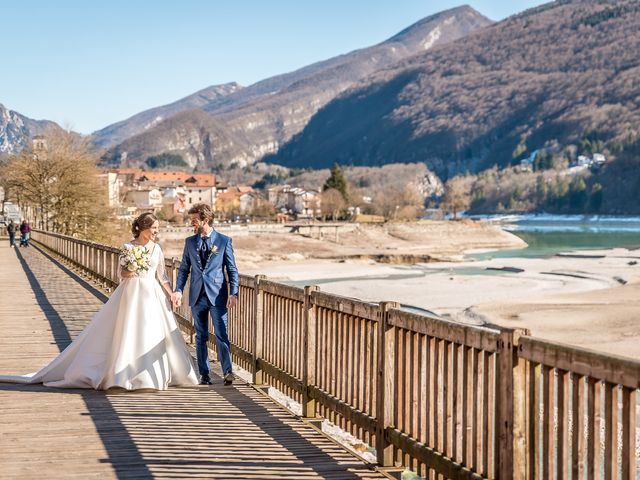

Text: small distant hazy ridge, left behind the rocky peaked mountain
xmin=92 ymin=82 xmax=242 ymax=147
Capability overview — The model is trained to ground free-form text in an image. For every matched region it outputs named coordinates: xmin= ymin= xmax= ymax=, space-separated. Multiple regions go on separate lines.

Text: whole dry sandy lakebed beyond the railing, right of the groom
xmin=162 ymin=222 xmax=640 ymax=358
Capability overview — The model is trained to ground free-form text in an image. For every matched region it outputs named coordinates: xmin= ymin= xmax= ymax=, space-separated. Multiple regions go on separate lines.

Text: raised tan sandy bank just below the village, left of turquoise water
xmin=163 ymin=220 xmax=526 ymax=271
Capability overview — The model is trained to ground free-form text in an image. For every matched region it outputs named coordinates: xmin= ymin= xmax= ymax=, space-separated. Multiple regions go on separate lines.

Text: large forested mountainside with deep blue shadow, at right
xmin=266 ymin=0 xmax=640 ymax=178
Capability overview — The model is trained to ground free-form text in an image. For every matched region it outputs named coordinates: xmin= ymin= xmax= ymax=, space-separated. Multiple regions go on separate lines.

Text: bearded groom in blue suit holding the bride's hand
xmin=172 ymin=203 xmax=238 ymax=385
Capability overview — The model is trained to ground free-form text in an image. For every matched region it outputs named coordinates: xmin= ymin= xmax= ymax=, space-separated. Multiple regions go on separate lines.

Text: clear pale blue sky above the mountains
xmin=0 ymin=0 xmax=545 ymax=133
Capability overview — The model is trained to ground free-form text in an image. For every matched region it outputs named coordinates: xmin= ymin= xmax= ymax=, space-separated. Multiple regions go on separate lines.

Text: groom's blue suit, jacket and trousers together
xmin=176 ymin=230 xmax=238 ymax=375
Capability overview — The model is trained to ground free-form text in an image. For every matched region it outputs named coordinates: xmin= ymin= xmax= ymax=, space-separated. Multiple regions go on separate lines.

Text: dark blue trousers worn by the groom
xmin=191 ymin=289 xmax=232 ymax=375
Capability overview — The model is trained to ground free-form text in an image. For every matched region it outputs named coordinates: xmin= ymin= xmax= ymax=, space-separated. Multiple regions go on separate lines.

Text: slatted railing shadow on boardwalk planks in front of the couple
xmin=100 ymin=375 xmax=379 ymax=480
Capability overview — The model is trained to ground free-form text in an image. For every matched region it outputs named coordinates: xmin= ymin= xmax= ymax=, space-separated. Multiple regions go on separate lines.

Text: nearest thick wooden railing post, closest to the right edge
xmin=494 ymin=328 xmax=527 ymax=480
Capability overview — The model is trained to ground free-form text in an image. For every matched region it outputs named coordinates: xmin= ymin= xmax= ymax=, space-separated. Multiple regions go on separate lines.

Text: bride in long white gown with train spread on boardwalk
xmin=0 ymin=213 xmax=198 ymax=390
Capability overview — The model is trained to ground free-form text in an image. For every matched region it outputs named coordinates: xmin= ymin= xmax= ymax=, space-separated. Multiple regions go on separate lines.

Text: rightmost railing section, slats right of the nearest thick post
xmin=518 ymin=337 xmax=640 ymax=479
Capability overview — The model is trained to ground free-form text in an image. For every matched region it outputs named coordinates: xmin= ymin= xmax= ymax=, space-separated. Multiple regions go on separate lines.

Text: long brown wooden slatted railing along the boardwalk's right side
xmin=33 ymin=231 xmax=640 ymax=480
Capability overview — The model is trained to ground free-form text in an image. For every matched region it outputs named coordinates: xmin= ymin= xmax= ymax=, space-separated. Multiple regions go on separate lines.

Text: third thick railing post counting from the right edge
xmin=302 ymin=285 xmax=320 ymax=418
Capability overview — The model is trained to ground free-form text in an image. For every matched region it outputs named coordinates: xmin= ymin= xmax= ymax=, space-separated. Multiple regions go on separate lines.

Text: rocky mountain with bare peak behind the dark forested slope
xmin=103 ymin=6 xmax=491 ymax=169
